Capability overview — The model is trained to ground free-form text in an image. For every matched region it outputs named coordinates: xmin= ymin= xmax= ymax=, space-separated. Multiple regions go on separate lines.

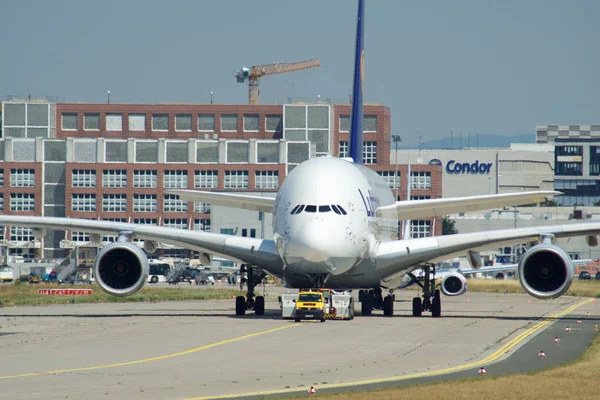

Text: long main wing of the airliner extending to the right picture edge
xmin=373 ymin=222 xmax=600 ymax=281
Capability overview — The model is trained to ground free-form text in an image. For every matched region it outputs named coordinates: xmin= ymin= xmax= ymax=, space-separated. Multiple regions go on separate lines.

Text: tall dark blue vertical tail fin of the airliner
xmin=349 ymin=0 xmax=365 ymax=164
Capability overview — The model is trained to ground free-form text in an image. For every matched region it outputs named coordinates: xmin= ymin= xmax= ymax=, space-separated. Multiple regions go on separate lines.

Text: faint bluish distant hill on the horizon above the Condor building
xmin=392 ymin=133 xmax=535 ymax=150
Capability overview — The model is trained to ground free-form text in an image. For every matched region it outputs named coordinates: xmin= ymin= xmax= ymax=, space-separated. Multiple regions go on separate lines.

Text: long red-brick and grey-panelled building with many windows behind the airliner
xmin=0 ymin=100 xmax=442 ymax=259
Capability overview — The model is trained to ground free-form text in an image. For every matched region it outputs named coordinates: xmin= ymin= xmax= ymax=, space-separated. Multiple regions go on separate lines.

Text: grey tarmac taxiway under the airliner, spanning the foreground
xmin=0 ymin=288 xmax=600 ymax=399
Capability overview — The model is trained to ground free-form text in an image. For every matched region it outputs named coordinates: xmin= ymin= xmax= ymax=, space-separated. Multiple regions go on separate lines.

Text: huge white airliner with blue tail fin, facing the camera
xmin=0 ymin=0 xmax=600 ymax=317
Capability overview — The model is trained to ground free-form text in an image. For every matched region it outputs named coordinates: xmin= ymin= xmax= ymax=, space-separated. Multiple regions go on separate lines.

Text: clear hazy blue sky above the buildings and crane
xmin=0 ymin=0 xmax=600 ymax=144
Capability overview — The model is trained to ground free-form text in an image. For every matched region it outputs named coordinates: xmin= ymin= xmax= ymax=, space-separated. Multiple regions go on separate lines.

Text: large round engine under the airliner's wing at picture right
xmin=518 ymin=244 xmax=575 ymax=300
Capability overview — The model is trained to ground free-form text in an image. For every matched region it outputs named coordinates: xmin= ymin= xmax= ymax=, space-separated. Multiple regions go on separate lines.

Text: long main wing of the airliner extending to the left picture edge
xmin=0 ymin=215 xmax=283 ymax=277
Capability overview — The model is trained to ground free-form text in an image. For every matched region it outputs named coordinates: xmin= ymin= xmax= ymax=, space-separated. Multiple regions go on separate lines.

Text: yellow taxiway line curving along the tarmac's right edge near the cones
xmin=186 ymin=299 xmax=594 ymax=400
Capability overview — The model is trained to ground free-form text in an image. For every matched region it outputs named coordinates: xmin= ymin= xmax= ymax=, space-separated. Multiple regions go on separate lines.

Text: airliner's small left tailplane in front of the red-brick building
xmin=165 ymin=189 xmax=275 ymax=213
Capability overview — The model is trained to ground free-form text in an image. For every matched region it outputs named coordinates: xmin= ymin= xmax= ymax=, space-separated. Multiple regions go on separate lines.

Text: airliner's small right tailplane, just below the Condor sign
xmin=375 ymin=190 xmax=562 ymax=221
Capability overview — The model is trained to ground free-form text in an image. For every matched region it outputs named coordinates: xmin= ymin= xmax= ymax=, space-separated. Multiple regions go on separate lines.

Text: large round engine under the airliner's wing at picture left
xmin=94 ymin=241 xmax=150 ymax=297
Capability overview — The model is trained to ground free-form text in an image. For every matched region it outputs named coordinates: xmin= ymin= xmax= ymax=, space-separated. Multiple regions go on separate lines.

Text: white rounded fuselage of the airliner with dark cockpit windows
xmin=273 ymin=157 xmax=398 ymax=288
